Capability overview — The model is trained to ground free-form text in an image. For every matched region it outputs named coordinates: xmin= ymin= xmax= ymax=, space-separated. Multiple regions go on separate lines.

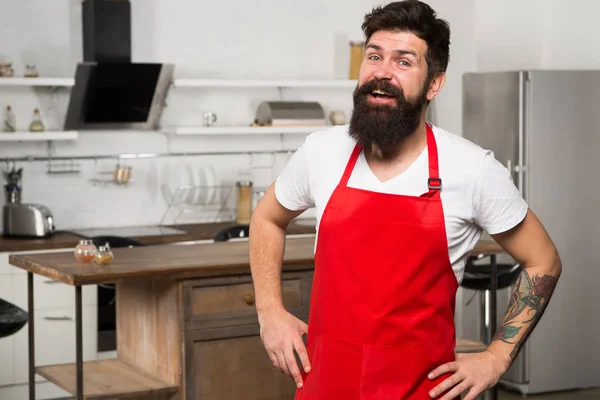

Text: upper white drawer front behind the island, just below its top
xmin=12 ymin=274 xmax=98 ymax=310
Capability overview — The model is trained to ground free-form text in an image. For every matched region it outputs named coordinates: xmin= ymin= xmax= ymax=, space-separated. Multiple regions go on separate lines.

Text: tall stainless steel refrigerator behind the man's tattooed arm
xmin=463 ymin=70 xmax=600 ymax=394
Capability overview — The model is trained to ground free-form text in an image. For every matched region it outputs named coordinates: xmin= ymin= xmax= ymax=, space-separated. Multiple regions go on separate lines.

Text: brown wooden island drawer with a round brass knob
xmin=183 ymin=271 xmax=312 ymax=329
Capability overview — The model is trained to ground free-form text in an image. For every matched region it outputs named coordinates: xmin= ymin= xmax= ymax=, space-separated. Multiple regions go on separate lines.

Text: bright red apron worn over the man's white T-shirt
xmin=295 ymin=126 xmax=458 ymax=400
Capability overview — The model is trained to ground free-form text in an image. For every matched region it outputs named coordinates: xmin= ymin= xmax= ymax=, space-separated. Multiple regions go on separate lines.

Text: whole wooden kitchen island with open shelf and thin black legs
xmin=9 ymin=238 xmax=501 ymax=400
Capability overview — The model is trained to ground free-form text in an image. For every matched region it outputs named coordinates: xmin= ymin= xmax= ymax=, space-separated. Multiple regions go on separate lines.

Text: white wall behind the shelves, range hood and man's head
xmin=10 ymin=0 xmax=597 ymax=233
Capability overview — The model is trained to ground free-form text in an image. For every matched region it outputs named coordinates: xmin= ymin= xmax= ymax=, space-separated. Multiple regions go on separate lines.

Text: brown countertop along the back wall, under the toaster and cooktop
xmin=0 ymin=221 xmax=315 ymax=253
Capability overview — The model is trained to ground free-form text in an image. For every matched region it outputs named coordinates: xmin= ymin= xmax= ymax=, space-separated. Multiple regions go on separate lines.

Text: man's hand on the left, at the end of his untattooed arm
xmin=259 ymin=308 xmax=310 ymax=388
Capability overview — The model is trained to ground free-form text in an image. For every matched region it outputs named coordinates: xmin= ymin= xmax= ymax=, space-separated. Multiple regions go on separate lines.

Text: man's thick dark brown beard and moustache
xmin=349 ymin=79 xmax=429 ymax=151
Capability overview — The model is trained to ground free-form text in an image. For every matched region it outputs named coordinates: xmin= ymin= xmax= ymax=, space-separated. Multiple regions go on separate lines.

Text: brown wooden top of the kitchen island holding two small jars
xmin=9 ymin=237 xmax=502 ymax=285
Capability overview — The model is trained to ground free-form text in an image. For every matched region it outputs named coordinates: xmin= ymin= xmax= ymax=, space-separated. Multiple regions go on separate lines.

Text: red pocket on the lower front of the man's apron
xmin=360 ymin=345 xmax=418 ymax=400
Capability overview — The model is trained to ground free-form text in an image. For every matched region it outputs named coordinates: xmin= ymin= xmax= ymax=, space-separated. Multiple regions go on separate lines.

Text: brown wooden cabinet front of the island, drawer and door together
xmin=182 ymin=272 xmax=313 ymax=400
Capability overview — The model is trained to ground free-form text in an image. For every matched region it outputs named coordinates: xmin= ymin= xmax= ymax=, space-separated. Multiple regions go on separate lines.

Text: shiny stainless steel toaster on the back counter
xmin=2 ymin=203 xmax=54 ymax=237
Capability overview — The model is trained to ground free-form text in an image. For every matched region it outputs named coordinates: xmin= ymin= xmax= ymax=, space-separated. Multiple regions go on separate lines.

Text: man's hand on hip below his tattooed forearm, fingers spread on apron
xmin=429 ymin=351 xmax=507 ymax=400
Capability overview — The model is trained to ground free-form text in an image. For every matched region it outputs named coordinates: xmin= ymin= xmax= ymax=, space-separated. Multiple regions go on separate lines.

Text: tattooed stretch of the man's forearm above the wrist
xmin=492 ymin=270 xmax=558 ymax=359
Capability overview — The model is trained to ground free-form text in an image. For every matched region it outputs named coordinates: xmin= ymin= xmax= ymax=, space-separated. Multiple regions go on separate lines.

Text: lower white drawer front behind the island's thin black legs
xmin=14 ymin=306 xmax=98 ymax=384
